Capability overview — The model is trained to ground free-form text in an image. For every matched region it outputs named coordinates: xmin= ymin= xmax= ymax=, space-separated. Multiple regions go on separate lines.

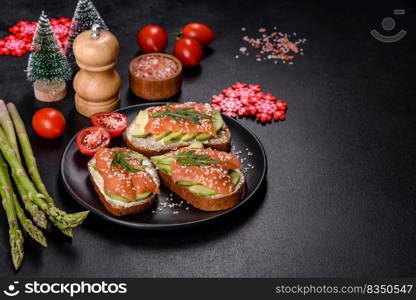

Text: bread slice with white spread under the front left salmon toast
xmin=88 ymin=152 xmax=160 ymax=217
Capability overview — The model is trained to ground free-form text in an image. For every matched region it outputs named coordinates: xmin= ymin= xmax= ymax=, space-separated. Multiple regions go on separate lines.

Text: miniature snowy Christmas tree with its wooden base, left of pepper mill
xmin=27 ymin=12 xmax=71 ymax=101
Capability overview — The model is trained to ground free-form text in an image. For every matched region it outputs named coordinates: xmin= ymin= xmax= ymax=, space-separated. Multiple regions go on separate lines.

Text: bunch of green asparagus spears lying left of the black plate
xmin=0 ymin=100 xmax=89 ymax=269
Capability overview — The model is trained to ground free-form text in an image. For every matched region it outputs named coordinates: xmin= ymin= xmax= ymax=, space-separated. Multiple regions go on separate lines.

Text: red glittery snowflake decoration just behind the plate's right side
xmin=211 ymin=82 xmax=287 ymax=123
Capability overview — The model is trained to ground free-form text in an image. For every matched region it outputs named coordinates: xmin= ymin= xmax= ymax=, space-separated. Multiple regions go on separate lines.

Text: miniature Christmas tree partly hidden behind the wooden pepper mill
xmin=66 ymin=0 xmax=108 ymax=64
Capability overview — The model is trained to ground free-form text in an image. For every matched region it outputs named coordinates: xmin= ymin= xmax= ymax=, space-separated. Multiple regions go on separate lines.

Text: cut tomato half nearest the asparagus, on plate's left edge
xmin=77 ymin=126 xmax=111 ymax=156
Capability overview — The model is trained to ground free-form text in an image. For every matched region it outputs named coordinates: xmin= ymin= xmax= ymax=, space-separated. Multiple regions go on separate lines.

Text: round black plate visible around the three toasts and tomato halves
xmin=61 ymin=102 xmax=267 ymax=229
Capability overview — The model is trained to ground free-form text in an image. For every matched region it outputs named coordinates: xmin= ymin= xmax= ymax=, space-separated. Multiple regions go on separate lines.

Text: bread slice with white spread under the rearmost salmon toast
xmin=125 ymin=108 xmax=231 ymax=157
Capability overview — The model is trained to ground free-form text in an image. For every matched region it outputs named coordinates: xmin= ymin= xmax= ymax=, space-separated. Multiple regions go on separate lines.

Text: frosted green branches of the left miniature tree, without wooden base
xmin=27 ymin=12 xmax=71 ymax=82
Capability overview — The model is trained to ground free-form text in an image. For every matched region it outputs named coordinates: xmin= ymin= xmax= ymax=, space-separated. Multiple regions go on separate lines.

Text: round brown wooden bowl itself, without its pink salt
xmin=129 ymin=53 xmax=182 ymax=101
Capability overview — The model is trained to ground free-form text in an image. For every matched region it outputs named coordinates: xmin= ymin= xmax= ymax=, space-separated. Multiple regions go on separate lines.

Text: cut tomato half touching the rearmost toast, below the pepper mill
xmin=90 ymin=112 xmax=127 ymax=137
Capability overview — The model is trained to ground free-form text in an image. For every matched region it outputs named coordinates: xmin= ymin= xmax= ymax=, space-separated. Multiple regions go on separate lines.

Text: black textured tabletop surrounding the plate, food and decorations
xmin=0 ymin=0 xmax=416 ymax=277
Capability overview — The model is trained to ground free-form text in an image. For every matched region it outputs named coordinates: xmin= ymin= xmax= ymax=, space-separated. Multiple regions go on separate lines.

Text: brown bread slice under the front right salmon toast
xmin=158 ymin=170 xmax=247 ymax=211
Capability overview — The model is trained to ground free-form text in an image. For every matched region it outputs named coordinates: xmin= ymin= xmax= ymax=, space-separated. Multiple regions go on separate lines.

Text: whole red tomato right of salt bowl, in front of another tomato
xmin=173 ymin=38 xmax=203 ymax=67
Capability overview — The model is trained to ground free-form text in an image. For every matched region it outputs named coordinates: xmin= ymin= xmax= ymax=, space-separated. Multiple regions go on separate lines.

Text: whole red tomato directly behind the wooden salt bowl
xmin=137 ymin=25 xmax=168 ymax=53
